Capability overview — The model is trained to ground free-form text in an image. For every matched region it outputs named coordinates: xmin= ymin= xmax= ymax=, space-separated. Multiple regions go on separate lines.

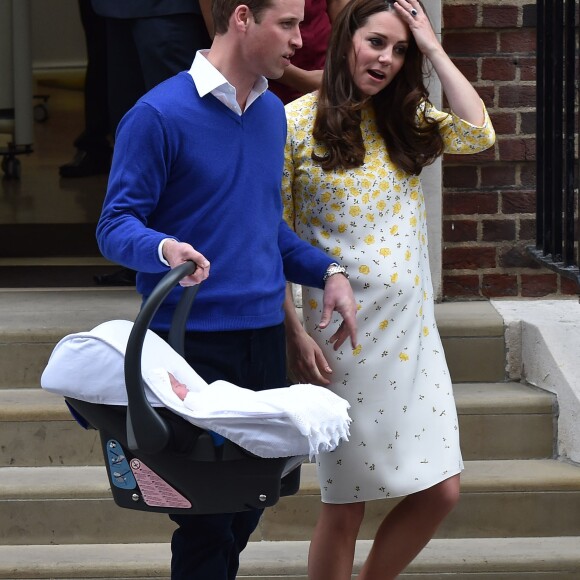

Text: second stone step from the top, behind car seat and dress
xmin=0 ymin=382 xmax=554 ymax=467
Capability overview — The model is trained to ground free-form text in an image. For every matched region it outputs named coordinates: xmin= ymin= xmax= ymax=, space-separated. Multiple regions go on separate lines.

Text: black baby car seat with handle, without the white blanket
xmin=65 ymin=262 xmax=304 ymax=514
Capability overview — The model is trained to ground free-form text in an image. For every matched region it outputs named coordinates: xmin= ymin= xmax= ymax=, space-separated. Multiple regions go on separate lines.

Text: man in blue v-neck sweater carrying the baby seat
xmin=97 ymin=0 xmax=356 ymax=580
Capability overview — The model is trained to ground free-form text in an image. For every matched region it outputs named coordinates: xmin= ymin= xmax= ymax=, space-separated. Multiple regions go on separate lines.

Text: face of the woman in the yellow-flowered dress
xmin=349 ymin=12 xmax=410 ymax=96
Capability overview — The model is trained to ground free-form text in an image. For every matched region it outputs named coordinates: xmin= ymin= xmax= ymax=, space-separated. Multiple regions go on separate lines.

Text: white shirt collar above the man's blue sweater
xmin=189 ymin=49 xmax=268 ymax=115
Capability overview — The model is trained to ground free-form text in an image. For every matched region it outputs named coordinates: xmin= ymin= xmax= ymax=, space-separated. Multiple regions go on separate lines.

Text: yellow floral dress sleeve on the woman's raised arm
xmin=419 ymin=101 xmax=495 ymax=155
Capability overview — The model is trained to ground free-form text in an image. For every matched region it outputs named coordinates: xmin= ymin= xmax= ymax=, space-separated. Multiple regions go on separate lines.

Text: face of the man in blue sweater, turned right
xmin=245 ymin=0 xmax=304 ymax=79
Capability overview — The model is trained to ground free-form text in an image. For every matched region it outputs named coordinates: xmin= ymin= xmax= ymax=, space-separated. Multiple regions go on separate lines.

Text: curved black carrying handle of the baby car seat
xmin=125 ymin=261 xmax=199 ymax=454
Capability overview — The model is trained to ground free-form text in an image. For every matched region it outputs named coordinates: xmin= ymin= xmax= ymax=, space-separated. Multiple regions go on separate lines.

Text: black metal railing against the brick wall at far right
xmin=528 ymin=0 xmax=580 ymax=287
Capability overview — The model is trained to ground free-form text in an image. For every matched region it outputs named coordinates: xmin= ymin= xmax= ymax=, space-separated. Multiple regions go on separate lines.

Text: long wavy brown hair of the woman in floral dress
xmin=312 ymin=0 xmax=443 ymax=174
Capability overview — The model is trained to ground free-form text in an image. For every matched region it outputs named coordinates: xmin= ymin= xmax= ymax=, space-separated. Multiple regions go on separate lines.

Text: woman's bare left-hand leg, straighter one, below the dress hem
xmin=308 ymin=503 xmax=365 ymax=580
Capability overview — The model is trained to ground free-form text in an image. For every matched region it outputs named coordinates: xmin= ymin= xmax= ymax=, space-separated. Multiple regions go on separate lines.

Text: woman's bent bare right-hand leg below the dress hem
xmin=358 ymin=475 xmax=459 ymax=580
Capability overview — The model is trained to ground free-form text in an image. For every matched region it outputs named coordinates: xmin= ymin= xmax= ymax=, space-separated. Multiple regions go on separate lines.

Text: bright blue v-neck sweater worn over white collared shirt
xmin=97 ymin=72 xmax=332 ymax=331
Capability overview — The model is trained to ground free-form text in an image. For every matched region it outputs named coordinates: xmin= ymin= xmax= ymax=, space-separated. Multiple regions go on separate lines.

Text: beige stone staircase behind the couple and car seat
xmin=0 ymin=288 xmax=580 ymax=580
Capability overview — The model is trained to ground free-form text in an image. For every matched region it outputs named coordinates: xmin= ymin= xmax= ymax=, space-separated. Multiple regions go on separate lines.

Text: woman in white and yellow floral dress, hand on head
xmin=282 ymin=0 xmax=495 ymax=580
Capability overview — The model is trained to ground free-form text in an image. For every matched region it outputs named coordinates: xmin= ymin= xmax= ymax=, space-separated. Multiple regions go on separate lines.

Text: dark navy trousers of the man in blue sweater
xmin=160 ymin=325 xmax=287 ymax=580
